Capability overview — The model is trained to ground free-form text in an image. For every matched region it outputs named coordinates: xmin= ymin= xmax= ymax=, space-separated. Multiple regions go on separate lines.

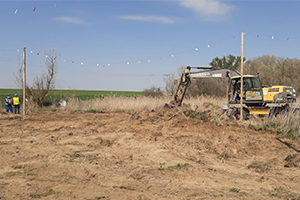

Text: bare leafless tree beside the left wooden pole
xmin=15 ymin=49 xmax=58 ymax=106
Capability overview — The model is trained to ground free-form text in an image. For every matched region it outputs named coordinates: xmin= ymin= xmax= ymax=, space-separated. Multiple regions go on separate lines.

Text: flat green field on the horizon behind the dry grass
xmin=0 ymin=89 xmax=144 ymax=108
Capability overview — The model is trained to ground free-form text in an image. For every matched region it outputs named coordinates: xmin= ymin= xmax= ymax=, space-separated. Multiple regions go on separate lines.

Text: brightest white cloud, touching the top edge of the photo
xmin=180 ymin=0 xmax=235 ymax=20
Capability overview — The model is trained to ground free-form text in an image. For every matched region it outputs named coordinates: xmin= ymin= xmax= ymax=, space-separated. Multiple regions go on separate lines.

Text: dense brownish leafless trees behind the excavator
xmin=188 ymin=55 xmax=300 ymax=97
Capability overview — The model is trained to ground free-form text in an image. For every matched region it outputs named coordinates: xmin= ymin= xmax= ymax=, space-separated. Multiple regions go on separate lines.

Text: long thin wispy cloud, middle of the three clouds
xmin=120 ymin=15 xmax=178 ymax=24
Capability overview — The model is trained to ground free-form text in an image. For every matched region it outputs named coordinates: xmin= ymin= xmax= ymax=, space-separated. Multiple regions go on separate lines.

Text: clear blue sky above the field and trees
xmin=0 ymin=0 xmax=300 ymax=91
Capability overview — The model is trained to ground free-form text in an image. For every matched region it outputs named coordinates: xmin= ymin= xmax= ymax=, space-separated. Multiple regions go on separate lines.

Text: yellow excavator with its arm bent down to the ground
xmin=171 ymin=66 xmax=296 ymax=120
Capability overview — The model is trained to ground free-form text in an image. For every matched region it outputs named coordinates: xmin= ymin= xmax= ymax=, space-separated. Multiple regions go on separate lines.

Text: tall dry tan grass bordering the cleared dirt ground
xmin=25 ymin=95 xmax=300 ymax=139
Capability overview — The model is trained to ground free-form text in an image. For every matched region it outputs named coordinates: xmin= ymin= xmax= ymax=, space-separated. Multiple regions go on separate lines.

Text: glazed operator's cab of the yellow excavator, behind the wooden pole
xmin=227 ymin=75 xmax=263 ymax=106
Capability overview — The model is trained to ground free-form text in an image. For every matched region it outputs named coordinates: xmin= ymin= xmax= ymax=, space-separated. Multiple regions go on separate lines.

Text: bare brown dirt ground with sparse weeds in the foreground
xmin=0 ymin=110 xmax=300 ymax=200
